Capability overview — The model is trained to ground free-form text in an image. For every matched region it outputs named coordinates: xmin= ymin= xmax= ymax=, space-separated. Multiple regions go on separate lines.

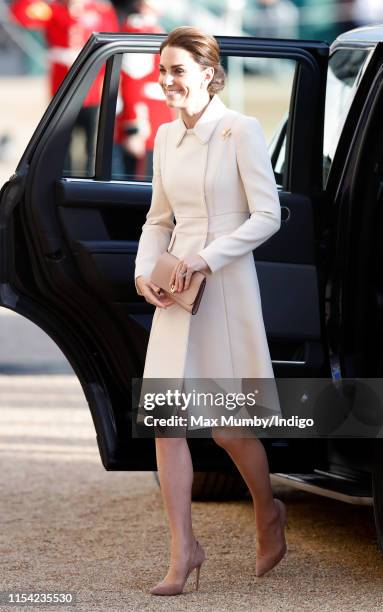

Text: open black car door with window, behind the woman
xmin=0 ymin=34 xmax=329 ymax=471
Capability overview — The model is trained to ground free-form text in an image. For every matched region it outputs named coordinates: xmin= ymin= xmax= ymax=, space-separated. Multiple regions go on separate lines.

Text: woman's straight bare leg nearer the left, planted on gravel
xmin=156 ymin=438 xmax=195 ymax=582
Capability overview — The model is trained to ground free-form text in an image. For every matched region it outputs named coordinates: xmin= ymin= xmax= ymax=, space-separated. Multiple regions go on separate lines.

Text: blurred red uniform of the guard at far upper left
xmin=10 ymin=0 xmax=119 ymax=106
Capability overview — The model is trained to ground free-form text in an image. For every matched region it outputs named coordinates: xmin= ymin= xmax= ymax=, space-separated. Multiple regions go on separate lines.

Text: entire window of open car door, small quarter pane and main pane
xmin=59 ymin=52 xmax=297 ymax=185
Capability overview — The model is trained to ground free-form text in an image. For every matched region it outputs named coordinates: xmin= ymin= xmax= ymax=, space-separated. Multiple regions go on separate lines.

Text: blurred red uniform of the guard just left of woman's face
xmin=117 ymin=13 xmax=176 ymax=151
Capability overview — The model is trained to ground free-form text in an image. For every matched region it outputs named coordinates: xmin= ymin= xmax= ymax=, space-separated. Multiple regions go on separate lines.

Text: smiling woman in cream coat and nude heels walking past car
xmin=135 ymin=26 xmax=286 ymax=595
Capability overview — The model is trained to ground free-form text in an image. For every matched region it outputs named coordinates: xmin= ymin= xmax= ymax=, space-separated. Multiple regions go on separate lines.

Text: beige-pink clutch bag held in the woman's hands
xmin=150 ymin=251 xmax=206 ymax=314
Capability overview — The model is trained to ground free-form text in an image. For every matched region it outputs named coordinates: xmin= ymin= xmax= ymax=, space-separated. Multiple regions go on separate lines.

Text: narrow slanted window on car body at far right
xmin=323 ymin=48 xmax=372 ymax=188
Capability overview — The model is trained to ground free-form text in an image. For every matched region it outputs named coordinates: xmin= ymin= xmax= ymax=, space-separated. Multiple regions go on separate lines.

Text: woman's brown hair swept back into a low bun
xmin=160 ymin=26 xmax=225 ymax=96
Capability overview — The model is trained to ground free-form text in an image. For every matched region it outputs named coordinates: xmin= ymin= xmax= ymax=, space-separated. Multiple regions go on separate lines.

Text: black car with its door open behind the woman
xmin=0 ymin=26 xmax=383 ymax=549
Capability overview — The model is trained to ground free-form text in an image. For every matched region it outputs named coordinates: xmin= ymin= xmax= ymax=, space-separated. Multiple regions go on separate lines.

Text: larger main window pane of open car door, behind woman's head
xmin=112 ymin=53 xmax=296 ymax=182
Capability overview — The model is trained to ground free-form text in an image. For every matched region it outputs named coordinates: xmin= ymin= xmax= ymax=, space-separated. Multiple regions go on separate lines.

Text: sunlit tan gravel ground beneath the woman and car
xmin=0 ymin=375 xmax=383 ymax=612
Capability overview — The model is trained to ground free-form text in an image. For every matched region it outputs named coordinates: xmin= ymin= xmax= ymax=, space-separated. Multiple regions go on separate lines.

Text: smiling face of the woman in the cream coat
xmin=158 ymin=46 xmax=214 ymax=108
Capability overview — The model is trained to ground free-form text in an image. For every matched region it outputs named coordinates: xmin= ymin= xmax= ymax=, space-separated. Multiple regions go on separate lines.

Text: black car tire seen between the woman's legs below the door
xmin=154 ymin=472 xmax=250 ymax=501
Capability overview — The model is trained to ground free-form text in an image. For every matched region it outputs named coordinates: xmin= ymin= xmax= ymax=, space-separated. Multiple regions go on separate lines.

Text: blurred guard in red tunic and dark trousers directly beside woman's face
xmin=113 ymin=0 xmax=176 ymax=179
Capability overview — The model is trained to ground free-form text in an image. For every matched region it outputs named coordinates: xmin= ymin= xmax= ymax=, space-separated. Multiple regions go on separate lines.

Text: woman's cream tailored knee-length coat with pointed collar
xmin=135 ymin=95 xmax=281 ymax=424
